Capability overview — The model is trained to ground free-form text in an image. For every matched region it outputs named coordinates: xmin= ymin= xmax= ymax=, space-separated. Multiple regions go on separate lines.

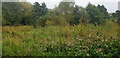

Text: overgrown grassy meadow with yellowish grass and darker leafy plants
xmin=2 ymin=22 xmax=120 ymax=56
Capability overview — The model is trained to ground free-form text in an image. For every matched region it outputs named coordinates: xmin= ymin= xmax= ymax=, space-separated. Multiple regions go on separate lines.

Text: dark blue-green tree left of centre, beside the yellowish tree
xmin=33 ymin=2 xmax=48 ymax=27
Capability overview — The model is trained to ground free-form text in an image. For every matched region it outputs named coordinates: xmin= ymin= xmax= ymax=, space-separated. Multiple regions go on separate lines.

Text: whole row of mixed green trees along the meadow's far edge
xmin=2 ymin=2 xmax=120 ymax=27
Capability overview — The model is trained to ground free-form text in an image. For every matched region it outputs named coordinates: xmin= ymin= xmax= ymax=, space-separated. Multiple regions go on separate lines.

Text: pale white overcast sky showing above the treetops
xmin=27 ymin=0 xmax=119 ymax=13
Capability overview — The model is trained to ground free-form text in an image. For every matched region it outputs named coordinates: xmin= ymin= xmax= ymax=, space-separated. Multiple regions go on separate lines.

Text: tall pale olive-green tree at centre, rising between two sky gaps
xmin=57 ymin=1 xmax=75 ymax=24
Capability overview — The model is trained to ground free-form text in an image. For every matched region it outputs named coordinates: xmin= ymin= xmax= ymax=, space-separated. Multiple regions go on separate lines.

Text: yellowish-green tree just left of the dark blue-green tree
xmin=20 ymin=3 xmax=33 ymax=25
